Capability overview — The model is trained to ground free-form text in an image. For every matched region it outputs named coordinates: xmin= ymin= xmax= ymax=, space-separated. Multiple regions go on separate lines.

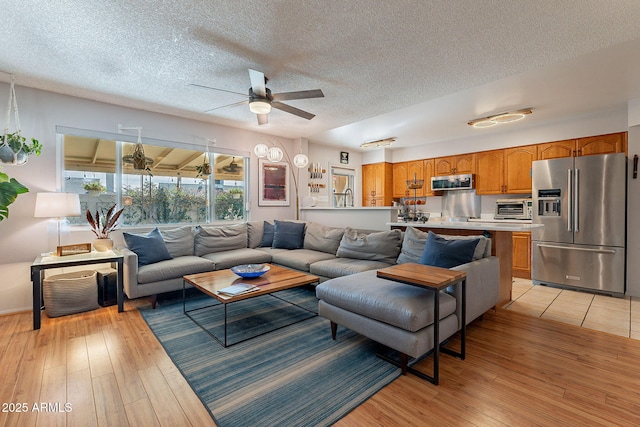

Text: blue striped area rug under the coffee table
xmin=140 ymin=288 xmax=400 ymax=427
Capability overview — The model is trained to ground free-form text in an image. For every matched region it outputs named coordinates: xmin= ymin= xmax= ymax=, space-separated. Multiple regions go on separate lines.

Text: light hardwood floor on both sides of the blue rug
xmin=0 ymin=294 xmax=640 ymax=427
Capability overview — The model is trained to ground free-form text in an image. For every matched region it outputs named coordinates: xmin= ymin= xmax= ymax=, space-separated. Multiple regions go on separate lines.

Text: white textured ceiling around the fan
xmin=0 ymin=0 xmax=640 ymax=147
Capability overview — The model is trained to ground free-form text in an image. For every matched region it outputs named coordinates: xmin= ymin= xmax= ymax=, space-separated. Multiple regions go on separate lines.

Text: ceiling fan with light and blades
xmin=190 ymin=69 xmax=324 ymax=125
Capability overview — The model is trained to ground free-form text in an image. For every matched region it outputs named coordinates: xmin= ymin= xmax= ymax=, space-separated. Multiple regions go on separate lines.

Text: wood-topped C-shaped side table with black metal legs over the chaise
xmin=377 ymin=263 xmax=467 ymax=385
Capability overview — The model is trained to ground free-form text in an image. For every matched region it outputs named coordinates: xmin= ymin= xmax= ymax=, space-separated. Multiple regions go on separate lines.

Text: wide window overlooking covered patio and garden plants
xmin=63 ymin=135 xmax=246 ymax=225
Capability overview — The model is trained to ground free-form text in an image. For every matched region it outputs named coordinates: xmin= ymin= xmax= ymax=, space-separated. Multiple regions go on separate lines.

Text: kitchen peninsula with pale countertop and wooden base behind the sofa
xmin=387 ymin=219 xmax=542 ymax=308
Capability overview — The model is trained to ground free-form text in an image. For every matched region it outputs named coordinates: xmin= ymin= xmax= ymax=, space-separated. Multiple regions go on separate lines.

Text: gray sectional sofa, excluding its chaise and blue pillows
xmin=119 ymin=221 xmax=499 ymax=322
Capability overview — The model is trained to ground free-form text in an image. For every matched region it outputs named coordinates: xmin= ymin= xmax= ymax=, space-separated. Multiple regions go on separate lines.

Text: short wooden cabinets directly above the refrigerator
xmin=537 ymin=132 xmax=627 ymax=160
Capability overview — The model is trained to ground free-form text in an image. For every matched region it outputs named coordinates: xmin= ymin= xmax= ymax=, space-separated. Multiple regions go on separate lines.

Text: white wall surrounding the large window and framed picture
xmin=0 ymin=84 xmax=302 ymax=314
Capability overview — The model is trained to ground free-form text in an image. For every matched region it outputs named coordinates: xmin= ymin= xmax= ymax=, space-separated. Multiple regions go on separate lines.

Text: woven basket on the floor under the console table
xmin=42 ymin=270 xmax=99 ymax=317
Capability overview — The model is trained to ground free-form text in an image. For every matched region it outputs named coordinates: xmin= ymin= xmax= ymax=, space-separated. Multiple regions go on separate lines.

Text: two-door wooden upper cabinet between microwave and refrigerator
xmin=476 ymin=145 xmax=537 ymax=194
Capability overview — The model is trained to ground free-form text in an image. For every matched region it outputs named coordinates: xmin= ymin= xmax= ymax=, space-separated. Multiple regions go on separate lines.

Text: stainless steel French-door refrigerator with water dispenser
xmin=531 ymin=153 xmax=627 ymax=294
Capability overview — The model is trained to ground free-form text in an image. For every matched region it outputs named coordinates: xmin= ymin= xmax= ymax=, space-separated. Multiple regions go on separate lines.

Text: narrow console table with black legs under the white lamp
xmin=31 ymin=250 xmax=124 ymax=329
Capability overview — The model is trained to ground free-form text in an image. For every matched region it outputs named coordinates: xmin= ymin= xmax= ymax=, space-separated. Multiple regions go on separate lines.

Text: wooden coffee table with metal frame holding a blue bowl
xmin=182 ymin=264 xmax=320 ymax=347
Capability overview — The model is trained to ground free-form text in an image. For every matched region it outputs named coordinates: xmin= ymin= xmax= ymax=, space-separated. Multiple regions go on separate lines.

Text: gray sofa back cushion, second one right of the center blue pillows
xmin=336 ymin=227 xmax=402 ymax=264
